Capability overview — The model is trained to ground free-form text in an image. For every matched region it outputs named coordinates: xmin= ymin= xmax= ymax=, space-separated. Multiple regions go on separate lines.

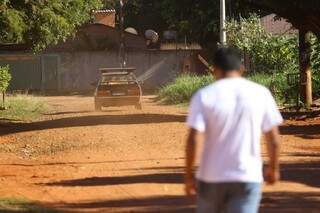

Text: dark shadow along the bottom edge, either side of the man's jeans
xmin=43 ymin=192 xmax=320 ymax=213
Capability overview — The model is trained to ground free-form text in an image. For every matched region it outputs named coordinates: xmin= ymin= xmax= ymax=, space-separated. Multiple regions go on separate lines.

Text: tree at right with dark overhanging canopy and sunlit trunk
xmin=244 ymin=0 xmax=320 ymax=106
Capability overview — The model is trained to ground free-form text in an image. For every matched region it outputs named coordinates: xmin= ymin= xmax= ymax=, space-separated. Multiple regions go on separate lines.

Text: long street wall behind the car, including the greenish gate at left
xmin=0 ymin=50 xmax=202 ymax=93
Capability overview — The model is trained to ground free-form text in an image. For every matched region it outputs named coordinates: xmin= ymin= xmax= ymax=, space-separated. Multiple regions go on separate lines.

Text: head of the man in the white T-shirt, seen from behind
xmin=213 ymin=47 xmax=242 ymax=79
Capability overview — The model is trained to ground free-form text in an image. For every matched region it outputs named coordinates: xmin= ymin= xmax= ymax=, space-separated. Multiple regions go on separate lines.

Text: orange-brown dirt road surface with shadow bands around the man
xmin=0 ymin=97 xmax=320 ymax=213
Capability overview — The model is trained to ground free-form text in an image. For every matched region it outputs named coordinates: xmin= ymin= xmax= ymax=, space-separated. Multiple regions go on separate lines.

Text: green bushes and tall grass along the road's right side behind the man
xmin=159 ymin=14 xmax=320 ymax=105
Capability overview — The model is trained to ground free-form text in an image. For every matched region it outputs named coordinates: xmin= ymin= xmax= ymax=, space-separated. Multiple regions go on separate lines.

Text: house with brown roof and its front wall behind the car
xmin=0 ymin=10 xmax=205 ymax=93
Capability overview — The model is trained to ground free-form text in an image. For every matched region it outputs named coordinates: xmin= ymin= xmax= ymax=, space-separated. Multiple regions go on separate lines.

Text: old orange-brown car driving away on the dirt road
xmin=94 ymin=68 xmax=142 ymax=111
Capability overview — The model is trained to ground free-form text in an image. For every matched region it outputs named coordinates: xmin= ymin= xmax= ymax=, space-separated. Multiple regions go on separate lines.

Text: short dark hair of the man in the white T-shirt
xmin=213 ymin=47 xmax=241 ymax=72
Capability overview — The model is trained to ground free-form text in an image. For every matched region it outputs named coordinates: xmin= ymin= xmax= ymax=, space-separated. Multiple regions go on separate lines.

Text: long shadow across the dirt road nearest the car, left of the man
xmin=0 ymin=114 xmax=186 ymax=136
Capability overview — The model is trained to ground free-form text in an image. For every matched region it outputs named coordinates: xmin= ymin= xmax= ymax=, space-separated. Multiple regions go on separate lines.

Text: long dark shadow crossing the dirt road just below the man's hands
xmin=45 ymin=162 xmax=320 ymax=187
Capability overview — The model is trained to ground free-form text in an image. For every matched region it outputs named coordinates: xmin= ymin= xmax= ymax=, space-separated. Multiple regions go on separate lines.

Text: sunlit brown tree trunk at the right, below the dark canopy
xmin=299 ymin=31 xmax=312 ymax=107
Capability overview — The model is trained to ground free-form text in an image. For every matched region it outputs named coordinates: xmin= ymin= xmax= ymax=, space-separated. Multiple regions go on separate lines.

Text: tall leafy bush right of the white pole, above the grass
xmin=226 ymin=14 xmax=298 ymax=73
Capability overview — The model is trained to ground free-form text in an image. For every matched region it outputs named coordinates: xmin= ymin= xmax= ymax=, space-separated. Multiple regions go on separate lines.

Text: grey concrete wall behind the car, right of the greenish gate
xmin=58 ymin=50 xmax=194 ymax=91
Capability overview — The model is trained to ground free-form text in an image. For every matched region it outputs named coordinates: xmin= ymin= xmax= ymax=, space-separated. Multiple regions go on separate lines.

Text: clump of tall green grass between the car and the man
xmin=158 ymin=75 xmax=213 ymax=104
